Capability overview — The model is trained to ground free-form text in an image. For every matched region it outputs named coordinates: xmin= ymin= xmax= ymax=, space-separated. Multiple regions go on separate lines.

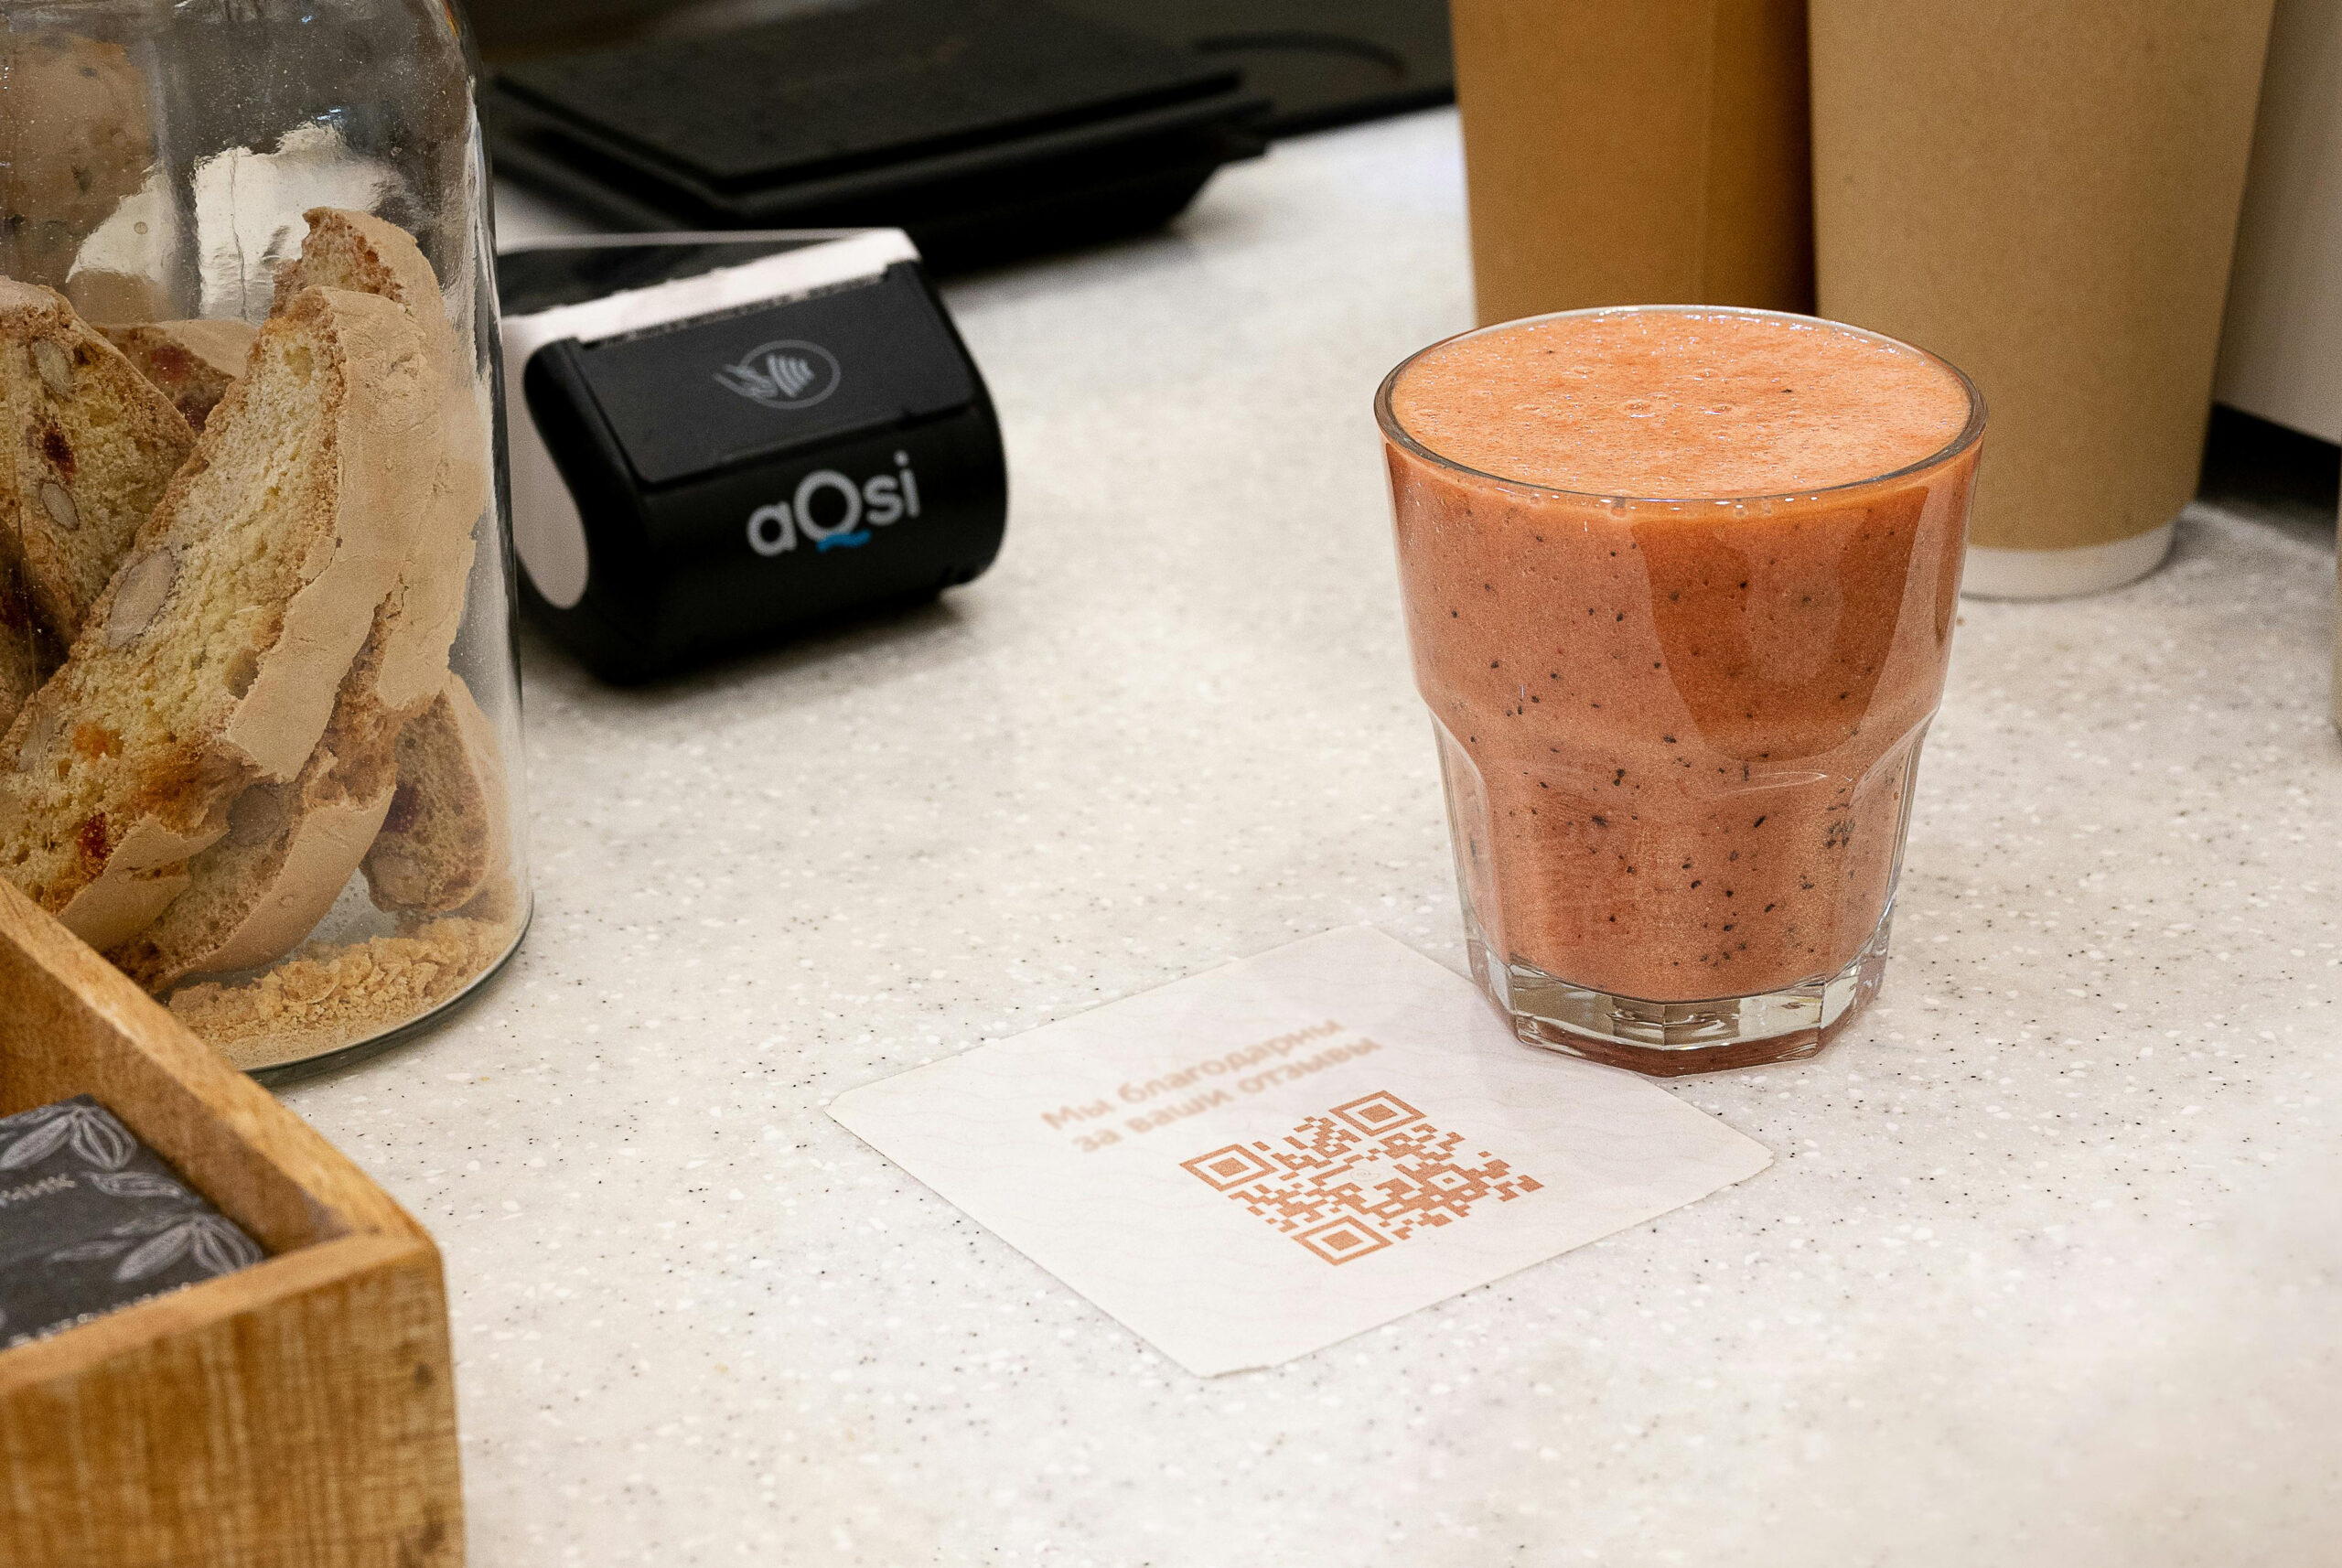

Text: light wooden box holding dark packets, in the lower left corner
xmin=0 ymin=882 xmax=464 ymax=1568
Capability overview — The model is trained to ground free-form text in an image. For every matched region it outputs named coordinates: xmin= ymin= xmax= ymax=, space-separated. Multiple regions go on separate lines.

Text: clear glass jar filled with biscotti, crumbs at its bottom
xmin=0 ymin=0 xmax=530 ymax=1077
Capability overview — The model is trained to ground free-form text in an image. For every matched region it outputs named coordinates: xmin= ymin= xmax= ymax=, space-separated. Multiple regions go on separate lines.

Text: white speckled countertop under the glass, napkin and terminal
xmin=288 ymin=114 xmax=2342 ymax=1568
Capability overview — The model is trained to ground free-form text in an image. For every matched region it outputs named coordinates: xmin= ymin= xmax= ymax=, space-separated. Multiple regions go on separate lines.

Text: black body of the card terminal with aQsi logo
xmin=506 ymin=263 xmax=1007 ymax=681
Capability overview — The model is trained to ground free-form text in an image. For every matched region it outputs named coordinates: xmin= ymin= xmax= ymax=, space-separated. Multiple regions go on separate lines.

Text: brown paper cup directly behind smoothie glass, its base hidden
xmin=1450 ymin=0 xmax=1812 ymax=326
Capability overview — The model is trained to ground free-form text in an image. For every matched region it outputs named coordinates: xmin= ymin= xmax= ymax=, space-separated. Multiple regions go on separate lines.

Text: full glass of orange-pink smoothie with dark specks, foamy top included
xmin=1375 ymin=306 xmax=1983 ymax=1074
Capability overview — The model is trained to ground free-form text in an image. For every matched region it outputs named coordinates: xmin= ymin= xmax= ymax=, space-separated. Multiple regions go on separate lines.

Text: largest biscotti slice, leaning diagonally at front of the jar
xmin=0 ymin=288 xmax=440 ymax=948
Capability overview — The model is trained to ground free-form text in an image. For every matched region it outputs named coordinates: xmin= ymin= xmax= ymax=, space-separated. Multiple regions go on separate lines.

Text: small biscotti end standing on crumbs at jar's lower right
xmin=365 ymin=674 xmax=513 ymax=918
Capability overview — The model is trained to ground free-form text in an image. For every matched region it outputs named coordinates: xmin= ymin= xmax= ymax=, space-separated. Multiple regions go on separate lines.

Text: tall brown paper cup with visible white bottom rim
xmin=1812 ymin=0 xmax=2272 ymax=599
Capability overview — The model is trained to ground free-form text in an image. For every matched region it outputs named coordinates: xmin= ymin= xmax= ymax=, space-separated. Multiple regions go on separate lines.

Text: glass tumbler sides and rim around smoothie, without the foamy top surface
xmin=1375 ymin=306 xmax=1983 ymax=1074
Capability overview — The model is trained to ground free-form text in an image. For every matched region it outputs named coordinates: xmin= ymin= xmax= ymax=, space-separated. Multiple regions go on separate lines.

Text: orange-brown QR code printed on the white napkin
xmin=1180 ymin=1093 xmax=1543 ymax=1263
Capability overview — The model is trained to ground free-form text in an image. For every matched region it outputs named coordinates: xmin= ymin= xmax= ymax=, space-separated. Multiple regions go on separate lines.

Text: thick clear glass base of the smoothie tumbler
xmin=1466 ymin=906 xmax=1895 ymax=1079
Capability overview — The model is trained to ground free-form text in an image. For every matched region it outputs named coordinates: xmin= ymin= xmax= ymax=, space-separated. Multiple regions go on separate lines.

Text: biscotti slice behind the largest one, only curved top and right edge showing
xmin=276 ymin=206 xmax=489 ymax=712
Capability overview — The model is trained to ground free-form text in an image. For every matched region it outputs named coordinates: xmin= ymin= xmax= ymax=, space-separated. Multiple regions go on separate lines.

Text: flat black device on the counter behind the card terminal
xmin=482 ymin=0 xmax=1264 ymax=267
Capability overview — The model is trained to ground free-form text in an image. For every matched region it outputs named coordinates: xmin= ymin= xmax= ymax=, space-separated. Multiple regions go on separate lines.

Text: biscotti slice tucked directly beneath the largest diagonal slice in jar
xmin=105 ymin=601 xmax=398 ymax=993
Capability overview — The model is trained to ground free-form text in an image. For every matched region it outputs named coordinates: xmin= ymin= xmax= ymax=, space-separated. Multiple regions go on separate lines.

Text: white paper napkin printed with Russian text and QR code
xmin=829 ymin=927 xmax=1773 ymax=1376
